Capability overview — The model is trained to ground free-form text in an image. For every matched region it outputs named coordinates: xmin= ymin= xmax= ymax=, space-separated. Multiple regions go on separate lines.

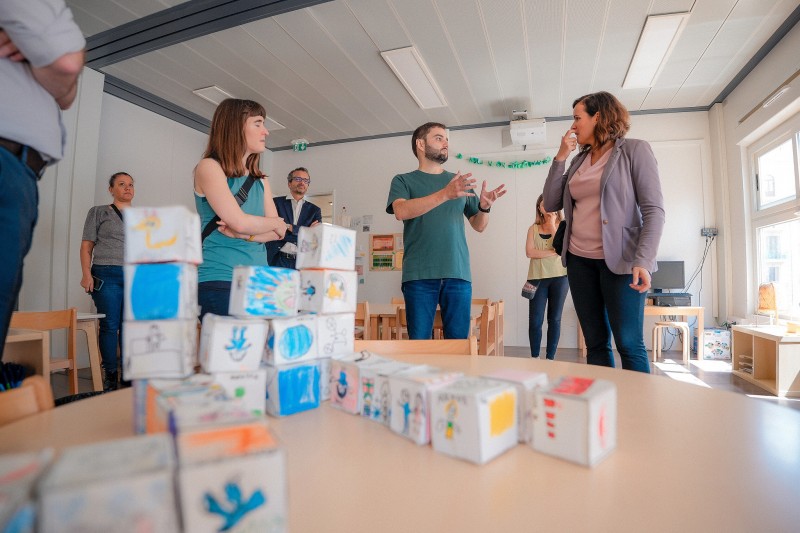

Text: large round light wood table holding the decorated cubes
xmin=0 ymin=355 xmax=800 ymax=533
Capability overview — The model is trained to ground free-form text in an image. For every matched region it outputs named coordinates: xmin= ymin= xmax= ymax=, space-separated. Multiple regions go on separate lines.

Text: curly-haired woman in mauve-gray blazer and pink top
xmin=544 ymin=92 xmax=664 ymax=372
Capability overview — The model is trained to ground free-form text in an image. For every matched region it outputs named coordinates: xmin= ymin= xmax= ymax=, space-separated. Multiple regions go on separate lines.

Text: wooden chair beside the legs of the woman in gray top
xmin=10 ymin=307 xmax=86 ymax=394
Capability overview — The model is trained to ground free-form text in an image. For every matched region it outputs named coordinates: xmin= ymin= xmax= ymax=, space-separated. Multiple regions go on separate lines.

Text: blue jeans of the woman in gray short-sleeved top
xmin=92 ymin=265 xmax=125 ymax=372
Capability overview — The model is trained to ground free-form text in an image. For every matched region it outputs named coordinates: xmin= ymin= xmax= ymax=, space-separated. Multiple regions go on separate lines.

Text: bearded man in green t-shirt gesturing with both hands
xmin=386 ymin=122 xmax=506 ymax=339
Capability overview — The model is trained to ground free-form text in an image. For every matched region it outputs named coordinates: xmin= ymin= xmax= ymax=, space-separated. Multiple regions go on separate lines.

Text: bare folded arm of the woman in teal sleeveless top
xmin=194 ymin=159 xmax=286 ymax=237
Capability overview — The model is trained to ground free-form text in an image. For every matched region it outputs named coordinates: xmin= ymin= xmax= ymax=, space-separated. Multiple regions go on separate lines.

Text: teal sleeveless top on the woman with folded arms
xmin=194 ymin=176 xmax=267 ymax=282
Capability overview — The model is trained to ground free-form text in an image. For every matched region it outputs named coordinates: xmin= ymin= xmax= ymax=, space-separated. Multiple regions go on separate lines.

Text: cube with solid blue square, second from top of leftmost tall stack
xmin=126 ymin=263 xmax=197 ymax=320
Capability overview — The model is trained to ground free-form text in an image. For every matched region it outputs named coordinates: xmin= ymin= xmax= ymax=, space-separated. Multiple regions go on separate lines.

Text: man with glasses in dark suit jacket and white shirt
xmin=267 ymin=167 xmax=322 ymax=268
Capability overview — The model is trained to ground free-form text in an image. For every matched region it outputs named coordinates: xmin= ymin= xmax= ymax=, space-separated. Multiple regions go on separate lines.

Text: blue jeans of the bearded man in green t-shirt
xmin=403 ymin=278 xmax=472 ymax=339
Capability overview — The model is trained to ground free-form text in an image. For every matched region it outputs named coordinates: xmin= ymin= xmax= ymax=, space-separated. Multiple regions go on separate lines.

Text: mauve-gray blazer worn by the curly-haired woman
xmin=543 ymin=138 xmax=664 ymax=274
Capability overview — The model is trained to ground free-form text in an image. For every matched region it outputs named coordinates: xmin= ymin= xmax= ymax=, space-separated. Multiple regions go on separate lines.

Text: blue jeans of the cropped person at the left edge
xmin=0 ymin=148 xmax=39 ymax=360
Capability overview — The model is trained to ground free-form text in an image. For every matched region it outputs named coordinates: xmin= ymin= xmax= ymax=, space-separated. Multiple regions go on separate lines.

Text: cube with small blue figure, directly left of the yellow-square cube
xmin=389 ymin=369 xmax=462 ymax=444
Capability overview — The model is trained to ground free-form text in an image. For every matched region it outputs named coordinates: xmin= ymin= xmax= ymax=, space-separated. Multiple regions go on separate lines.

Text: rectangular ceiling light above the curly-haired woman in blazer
xmin=622 ymin=12 xmax=689 ymax=89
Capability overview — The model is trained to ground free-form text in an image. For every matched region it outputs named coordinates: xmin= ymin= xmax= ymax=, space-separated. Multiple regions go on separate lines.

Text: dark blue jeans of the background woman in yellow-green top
xmin=528 ymin=276 xmax=569 ymax=359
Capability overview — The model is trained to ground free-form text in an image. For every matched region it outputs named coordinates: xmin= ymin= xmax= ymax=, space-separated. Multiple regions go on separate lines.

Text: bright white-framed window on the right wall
xmin=749 ymin=115 xmax=800 ymax=319
